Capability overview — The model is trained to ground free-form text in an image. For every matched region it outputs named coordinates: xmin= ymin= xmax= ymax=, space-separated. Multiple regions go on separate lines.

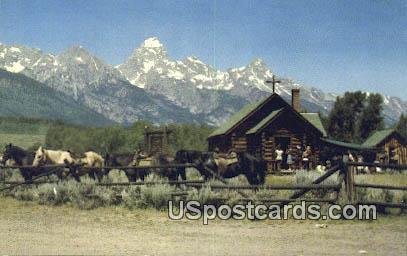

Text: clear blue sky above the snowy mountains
xmin=0 ymin=0 xmax=407 ymax=99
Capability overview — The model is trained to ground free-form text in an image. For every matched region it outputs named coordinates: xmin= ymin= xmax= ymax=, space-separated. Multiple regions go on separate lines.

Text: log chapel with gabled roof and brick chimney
xmin=208 ymin=89 xmax=327 ymax=171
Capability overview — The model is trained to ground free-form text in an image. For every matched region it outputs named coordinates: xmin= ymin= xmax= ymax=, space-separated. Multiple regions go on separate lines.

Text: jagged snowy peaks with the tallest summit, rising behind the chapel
xmin=117 ymin=37 xmax=407 ymax=124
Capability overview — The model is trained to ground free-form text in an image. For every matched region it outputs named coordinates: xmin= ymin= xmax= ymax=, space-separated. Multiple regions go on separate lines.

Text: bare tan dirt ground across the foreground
xmin=0 ymin=197 xmax=407 ymax=255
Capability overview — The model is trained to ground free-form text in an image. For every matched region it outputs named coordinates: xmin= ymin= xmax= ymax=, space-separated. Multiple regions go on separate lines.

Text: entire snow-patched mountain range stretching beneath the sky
xmin=0 ymin=37 xmax=407 ymax=125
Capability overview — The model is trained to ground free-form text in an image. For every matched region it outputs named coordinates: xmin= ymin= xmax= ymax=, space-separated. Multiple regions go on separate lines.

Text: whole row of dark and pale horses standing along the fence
xmin=1 ymin=144 xmax=266 ymax=185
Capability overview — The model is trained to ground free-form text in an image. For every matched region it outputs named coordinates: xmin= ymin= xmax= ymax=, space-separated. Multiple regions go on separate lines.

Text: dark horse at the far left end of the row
xmin=2 ymin=144 xmax=51 ymax=182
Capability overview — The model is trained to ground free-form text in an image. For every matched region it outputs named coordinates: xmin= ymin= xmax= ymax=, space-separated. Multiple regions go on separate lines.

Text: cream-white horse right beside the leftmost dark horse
xmin=32 ymin=147 xmax=75 ymax=166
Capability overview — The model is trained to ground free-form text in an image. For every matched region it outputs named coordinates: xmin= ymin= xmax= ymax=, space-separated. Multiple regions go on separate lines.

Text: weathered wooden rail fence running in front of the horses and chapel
xmin=0 ymin=162 xmax=407 ymax=209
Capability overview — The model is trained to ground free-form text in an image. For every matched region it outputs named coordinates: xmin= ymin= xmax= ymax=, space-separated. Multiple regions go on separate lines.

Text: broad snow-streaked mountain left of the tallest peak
xmin=0 ymin=41 xmax=202 ymax=124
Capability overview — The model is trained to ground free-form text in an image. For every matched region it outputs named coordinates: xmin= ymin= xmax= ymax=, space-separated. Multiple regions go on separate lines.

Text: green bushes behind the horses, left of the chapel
xmin=45 ymin=121 xmax=214 ymax=154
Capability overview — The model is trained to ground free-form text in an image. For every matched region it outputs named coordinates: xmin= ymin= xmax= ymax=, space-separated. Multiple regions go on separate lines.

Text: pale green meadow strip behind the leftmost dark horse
xmin=0 ymin=133 xmax=45 ymax=149
